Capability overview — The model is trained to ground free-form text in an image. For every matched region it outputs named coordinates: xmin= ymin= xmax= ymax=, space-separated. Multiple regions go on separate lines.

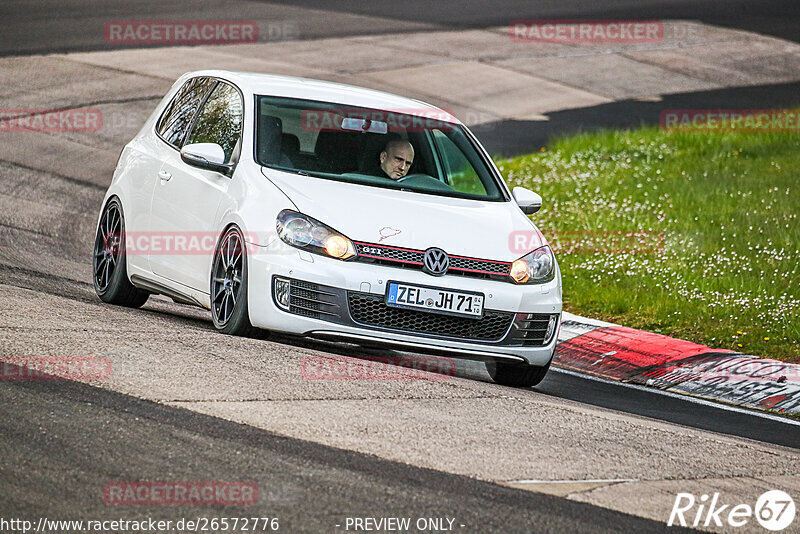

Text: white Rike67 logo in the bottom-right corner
xmin=667 ymin=490 xmax=796 ymax=532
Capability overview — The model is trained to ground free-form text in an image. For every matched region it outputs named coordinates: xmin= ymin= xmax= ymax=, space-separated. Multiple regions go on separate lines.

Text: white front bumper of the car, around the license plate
xmin=248 ymin=244 xmax=561 ymax=365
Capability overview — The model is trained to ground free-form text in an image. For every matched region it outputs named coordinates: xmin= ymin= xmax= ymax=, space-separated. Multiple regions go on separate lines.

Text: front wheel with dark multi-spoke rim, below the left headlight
xmin=210 ymin=226 xmax=263 ymax=337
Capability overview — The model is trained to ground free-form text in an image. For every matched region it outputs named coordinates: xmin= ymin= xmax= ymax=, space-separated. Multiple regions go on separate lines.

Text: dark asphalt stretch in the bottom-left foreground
xmin=0 ymin=376 xmax=684 ymax=532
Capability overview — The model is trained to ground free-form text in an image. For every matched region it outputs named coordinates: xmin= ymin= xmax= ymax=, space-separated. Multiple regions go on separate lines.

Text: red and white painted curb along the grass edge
xmin=553 ymin=313 xmax=800 ymax=414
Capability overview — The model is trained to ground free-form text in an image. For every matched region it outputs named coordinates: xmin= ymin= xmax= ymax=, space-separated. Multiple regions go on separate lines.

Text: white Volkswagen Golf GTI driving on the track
xmin=93 ymin=71 xmax=561 ymax=386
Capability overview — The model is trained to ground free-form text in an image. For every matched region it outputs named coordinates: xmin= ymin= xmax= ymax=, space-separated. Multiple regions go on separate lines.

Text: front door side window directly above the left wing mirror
xmin=186 ymin=82 xmax=243 ymax=163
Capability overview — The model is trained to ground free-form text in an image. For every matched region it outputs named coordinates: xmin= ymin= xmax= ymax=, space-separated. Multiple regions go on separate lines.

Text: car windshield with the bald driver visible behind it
xmin=255 ymin=96 xmax=506 ymax=201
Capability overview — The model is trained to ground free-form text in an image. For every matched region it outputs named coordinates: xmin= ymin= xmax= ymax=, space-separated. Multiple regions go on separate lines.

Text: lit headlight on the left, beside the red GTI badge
xmin=275 ymin=210 xmax=356 ymax=260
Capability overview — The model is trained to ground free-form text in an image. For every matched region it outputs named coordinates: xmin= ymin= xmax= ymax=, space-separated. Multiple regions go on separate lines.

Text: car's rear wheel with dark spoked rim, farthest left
xmin=92 ymin=197 xmax=150 ymax=308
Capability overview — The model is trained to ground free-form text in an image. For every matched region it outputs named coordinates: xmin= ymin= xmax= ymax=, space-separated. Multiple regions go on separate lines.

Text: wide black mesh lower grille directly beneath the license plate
xmin=347 ymin=291 xmax=514 ymax=341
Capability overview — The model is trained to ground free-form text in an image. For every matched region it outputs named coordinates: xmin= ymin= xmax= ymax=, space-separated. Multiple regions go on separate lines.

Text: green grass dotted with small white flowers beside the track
xmin=498 ymin=128 xmax=800 ymax=362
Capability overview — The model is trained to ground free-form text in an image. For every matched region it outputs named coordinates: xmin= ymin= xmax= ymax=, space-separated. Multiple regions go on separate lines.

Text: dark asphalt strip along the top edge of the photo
xmin=0 ymin=0 xmax=800 ymax=55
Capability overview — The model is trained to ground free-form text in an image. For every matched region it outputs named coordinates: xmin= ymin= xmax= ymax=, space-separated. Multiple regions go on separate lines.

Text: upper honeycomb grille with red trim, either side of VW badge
xmin=355 ymin=242 xmax=511 ymax=282
